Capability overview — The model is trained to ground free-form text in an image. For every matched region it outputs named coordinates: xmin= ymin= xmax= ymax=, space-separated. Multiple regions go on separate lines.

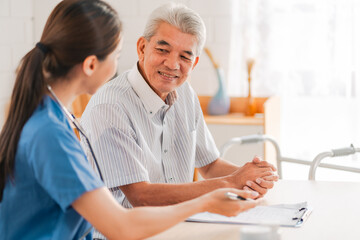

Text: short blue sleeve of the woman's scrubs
xmin=29 ymin=124 xmax=104 ymax=211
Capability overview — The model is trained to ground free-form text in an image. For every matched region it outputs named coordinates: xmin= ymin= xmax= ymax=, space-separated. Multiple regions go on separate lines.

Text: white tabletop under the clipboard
xmin=149 ymin=180 xmax=360 ymax=240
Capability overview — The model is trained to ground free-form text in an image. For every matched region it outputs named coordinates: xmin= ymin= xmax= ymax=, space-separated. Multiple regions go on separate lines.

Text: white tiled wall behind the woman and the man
xmin=0 ymin=0 xmax=231 ymax=126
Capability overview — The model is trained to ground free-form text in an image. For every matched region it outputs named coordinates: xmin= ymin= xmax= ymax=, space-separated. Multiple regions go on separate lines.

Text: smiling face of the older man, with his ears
xmin=137 ymin=22 xmax=199 ymax=100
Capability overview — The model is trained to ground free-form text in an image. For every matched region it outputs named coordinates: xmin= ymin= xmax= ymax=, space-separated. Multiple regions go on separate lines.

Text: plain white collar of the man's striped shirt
xmin=128 ymin=63 xmax=177 ymax=116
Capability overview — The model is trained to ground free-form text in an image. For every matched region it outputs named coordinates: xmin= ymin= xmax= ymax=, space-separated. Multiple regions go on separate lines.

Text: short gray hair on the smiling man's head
xmin=144 ymin=2 xmax=206 ymax=56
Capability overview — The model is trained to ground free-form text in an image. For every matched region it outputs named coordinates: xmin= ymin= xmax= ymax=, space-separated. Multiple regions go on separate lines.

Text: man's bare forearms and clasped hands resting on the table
xmin=120 ymin=156 xmax=278 ymax=207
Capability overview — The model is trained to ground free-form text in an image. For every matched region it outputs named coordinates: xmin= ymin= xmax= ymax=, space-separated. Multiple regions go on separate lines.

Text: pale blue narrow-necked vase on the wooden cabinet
xmin=207 ymin=67 xmax=230 ymax=115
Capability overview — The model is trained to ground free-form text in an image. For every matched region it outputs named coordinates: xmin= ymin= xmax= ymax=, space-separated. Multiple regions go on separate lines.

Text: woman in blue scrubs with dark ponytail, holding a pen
xmin=0 ymin=0 xmax=255 ymax=239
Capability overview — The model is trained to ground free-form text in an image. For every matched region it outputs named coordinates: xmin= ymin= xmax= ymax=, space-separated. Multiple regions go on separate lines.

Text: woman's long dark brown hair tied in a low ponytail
xmin=0 ymin=0 xmax=122 ymax=201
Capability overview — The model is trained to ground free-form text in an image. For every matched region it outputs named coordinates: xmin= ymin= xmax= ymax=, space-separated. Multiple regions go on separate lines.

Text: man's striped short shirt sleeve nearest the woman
xmin=82 ymin=104 xmax=150 ymax=188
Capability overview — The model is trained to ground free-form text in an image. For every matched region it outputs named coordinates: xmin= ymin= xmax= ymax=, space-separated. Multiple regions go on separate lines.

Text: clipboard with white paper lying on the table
xmin=186 ymin=202 xmax=312 ymax=227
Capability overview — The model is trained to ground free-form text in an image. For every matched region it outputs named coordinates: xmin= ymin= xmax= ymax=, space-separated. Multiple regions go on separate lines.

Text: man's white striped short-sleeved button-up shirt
xmin=81 ymin=64 xmax=219 ymax=207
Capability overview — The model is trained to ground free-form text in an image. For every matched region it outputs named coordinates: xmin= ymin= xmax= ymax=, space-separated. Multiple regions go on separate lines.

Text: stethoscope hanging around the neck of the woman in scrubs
xmin=47 ymin=85 xmax=104 ymax=182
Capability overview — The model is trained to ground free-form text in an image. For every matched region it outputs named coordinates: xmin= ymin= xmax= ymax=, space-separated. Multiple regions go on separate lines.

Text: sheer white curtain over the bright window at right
xmin=228 ymin=0 xmax=360 ymax=179
